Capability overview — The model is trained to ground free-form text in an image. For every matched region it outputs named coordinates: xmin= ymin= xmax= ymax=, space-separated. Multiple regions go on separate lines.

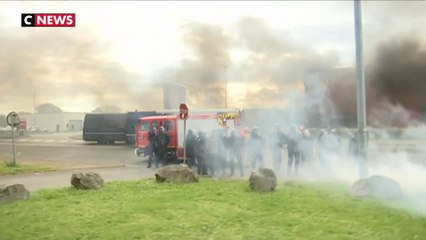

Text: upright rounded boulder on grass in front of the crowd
xmin=249 ymin=168 xmax=277 ymax=192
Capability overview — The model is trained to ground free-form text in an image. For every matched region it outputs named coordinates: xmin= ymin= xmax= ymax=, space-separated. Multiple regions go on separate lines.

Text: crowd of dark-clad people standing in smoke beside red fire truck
xmin=146 ymin=125 xmax=360 ymax=176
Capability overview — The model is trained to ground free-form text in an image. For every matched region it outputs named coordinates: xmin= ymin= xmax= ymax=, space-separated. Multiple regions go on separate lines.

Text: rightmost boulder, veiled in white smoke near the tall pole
xmin=349 ymin=175 xmax=403 ymax=200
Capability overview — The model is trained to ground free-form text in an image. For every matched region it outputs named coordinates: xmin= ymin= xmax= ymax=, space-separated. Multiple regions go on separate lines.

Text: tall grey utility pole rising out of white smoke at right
xmin=354 ymin=0 xmax=368 ymax=178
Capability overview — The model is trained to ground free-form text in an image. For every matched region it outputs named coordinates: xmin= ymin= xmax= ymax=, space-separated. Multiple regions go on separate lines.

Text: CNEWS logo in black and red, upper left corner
xmin=21 ymin=13 xmax=75 ymax=27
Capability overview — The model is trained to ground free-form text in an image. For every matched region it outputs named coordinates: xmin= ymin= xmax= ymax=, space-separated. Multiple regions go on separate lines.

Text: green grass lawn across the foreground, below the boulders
xmin=0 ymin=178 xmax=426 ymax=240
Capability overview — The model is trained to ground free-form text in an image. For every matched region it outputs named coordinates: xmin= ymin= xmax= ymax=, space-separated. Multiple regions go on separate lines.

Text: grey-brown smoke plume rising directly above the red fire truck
xmin=159 ymin=23 xmax=232 ymax=108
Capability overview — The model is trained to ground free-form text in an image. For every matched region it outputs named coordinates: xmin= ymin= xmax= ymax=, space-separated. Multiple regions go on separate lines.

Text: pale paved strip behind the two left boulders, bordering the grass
xmin=0 ymin=166 xmax=158 ymax=191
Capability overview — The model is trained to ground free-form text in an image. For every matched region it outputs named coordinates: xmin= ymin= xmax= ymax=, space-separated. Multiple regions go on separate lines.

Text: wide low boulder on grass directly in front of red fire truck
xmin=155 ymin=164 xmax=199 ymax=183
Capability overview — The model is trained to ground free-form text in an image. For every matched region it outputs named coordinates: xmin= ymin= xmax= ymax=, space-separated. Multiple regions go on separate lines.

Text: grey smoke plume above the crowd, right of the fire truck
xmin=237 ymin=17 xmax=338 ymax=107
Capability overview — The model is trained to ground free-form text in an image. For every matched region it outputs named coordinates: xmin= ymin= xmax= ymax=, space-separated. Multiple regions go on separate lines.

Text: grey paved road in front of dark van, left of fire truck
xmin=0 ymin=130 xmax=141 ymax=168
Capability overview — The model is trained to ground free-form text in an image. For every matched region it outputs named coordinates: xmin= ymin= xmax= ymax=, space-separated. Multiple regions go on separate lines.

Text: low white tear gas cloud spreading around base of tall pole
xmin=300 ymin=143 xmax=426 ymax=216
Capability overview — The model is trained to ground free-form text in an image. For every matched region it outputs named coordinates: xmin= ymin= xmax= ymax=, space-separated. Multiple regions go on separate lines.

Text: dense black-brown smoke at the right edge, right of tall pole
xmin=368 ymin=37 xmax=426 ymax=126
